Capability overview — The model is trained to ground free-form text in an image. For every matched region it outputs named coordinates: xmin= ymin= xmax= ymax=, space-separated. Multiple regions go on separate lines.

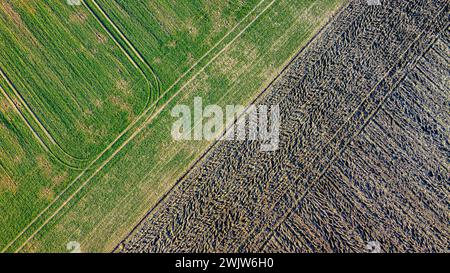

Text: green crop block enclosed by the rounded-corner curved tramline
xmin=0 ymin=0 xmax=150 ymax=161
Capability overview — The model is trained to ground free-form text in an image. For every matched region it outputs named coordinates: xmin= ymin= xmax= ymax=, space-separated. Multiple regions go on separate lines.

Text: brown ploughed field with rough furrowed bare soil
xmin=117 ymin=0 xmax=450 ymax=252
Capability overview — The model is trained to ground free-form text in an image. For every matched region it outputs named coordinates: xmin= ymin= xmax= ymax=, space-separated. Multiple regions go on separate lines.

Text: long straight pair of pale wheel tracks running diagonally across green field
xmin=2 ymin=0 xmax=277 ymax=252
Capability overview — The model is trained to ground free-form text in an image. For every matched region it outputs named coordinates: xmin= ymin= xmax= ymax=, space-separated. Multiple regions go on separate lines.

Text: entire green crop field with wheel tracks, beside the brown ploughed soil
xmin=0 ymin=0 xmax=344 ymax=252
